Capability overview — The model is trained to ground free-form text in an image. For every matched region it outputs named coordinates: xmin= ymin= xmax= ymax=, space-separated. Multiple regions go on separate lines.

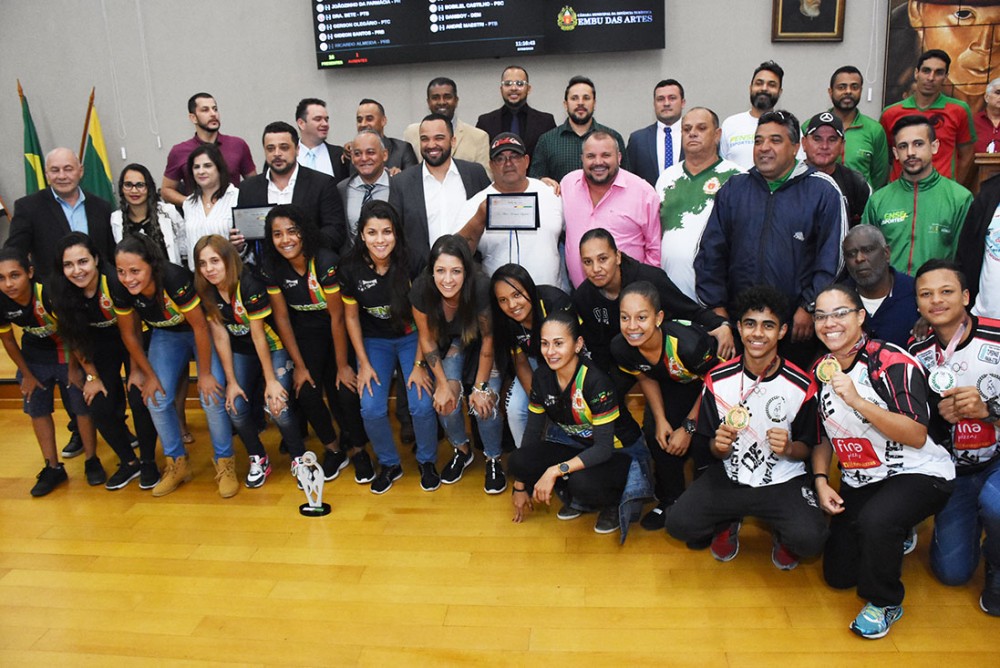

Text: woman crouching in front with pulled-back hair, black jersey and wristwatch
xmin=509 ymin=311 xmax=645 ymax=533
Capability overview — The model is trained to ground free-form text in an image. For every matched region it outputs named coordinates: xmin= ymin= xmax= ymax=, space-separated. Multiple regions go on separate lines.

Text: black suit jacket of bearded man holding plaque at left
xmin=237 ymin=166 xmax=347 ymax=251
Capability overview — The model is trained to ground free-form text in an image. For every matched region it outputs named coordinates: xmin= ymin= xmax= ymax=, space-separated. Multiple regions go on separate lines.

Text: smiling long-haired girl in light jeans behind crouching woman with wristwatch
xmin=490 ymin=264 xmax=573 ymax=447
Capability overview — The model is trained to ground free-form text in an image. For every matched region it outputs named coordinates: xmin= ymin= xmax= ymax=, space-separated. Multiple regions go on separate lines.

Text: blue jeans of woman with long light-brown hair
xmin=229 ymin=349 xmax=306 ymax=458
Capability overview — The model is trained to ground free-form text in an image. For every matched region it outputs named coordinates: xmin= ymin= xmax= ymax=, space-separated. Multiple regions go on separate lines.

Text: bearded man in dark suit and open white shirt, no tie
xmin=389 ymin=114 xmax=490 ymax=262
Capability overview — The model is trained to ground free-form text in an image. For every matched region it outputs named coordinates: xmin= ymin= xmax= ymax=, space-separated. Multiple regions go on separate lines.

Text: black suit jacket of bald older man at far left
xmin=4 ymin=188 xmax=115 ymax=278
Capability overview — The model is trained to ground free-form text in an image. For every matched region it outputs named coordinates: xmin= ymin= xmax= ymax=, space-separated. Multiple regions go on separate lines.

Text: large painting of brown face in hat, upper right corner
xmin=882 ymin=0 xmax=1000 ymax=114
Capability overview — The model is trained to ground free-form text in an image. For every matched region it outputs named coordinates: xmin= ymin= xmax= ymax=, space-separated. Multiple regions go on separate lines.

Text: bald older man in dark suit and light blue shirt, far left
xmin=5 ymin=148 xmax=115 ymax=278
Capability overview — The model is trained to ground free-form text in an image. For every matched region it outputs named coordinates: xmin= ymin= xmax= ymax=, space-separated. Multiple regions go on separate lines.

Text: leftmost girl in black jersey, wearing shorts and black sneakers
xmin=0 ymin=248 xmax=107 ymax=496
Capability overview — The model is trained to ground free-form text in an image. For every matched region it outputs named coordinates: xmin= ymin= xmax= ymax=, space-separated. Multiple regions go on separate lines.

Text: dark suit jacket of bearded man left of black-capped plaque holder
xmin=389 ymin=159 xmax=490 ymax=266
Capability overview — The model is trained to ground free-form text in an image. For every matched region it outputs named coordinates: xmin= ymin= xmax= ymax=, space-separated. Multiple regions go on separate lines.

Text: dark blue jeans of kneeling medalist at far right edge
xmin=931 ymin=460 xmax=1000 ymax=586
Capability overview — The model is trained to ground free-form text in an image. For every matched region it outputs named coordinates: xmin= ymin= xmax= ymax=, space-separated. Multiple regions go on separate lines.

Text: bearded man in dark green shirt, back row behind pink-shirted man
xmin=528 ymin=75 xmax=628 ymax=183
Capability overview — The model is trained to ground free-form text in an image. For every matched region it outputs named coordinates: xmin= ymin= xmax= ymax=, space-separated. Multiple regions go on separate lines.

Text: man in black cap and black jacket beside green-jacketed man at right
xmin=802 ymin=111 xmax=872 ymax=227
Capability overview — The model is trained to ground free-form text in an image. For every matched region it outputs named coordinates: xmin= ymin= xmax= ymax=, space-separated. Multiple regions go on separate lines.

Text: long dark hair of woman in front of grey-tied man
xmin=342 ymin=200 xmax=413 ymax=335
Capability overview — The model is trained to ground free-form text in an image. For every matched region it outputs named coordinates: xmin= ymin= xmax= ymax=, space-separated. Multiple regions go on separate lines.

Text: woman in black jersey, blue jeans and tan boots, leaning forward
xmin=108 ymin=234 xmax=239 ymax=498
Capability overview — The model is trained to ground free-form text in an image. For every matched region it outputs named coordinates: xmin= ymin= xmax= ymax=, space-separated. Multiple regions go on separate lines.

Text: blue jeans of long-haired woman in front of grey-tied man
xmin=361 ymin=332 xmax=437 ymax=467
